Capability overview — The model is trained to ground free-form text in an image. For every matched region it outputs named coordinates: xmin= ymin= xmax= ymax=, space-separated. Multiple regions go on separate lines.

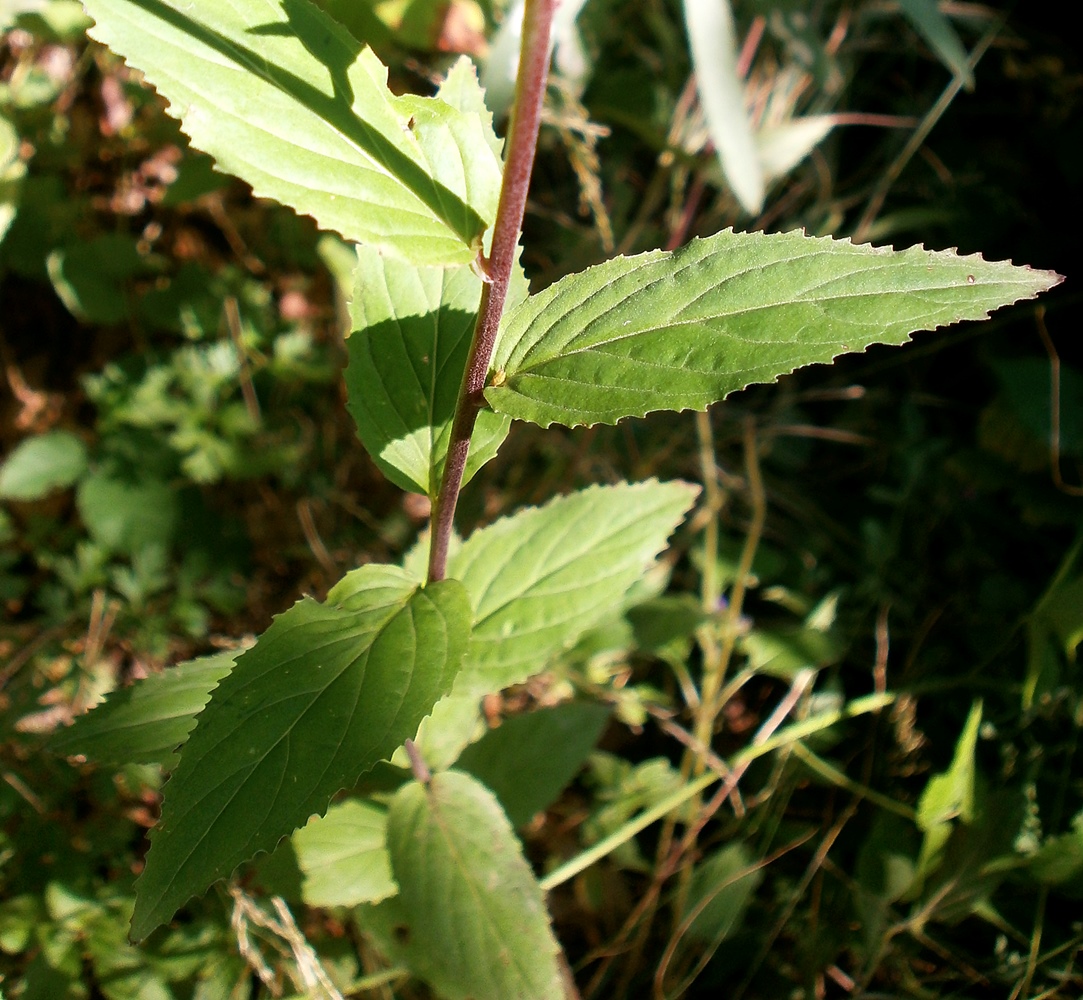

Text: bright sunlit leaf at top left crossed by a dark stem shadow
xmin=84 ymin=0 xmax=500 ymax=264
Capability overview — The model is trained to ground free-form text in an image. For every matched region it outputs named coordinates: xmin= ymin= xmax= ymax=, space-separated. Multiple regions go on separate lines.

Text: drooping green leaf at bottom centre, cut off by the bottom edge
xmin=388 ymin=771 xmax=564 ymax=1000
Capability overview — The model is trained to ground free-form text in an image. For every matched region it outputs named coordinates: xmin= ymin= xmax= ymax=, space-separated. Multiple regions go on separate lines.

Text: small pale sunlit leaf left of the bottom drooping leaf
xmin=293 ymin=798 xmax=399 ymax=906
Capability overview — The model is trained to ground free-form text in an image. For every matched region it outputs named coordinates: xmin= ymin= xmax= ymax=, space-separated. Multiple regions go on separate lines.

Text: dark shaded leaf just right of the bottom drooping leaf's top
xmin=455 ymin=701 xmax=611 ymax=827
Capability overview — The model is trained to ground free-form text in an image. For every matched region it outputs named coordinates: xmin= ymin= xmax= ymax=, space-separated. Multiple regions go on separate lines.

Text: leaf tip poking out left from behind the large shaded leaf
xmin=49 ymin=650 xmax=238 ymax=770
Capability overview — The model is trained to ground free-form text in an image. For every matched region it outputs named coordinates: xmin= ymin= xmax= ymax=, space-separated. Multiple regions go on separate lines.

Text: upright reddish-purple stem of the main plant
xmin=429 ymin=0 xmax=557 ymax=583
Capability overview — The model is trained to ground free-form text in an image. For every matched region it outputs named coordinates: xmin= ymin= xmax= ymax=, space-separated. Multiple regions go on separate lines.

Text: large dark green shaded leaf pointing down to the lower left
xmin=132 ymin=567 xmax=470 ymax=939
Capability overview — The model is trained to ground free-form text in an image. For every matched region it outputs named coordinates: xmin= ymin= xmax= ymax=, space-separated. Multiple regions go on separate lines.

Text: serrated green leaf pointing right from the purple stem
xmin=485 ymin=230 xmax=1060 ymax=426
